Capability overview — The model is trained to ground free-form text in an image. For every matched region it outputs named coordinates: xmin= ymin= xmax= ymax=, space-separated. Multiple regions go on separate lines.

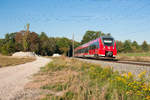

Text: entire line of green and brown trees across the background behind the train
xmin=0 ymin=30 xmax=150 ymax=56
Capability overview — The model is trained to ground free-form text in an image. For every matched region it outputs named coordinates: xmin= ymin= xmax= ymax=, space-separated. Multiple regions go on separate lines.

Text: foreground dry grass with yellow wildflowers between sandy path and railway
xmin=26 ymin=57 xmax=150 ymax=100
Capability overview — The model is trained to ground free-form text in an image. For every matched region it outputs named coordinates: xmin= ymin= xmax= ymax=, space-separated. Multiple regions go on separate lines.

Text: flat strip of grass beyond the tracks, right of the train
xmin=117 ymin=52 xmax=150 ymax=62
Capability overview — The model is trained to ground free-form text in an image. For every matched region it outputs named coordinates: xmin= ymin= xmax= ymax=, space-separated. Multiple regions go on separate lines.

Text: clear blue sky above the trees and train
xmin=0 ymin=0 xmax=150 ymax=43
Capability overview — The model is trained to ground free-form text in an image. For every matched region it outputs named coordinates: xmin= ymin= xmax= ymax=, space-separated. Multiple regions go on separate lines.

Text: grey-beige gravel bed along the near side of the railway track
xmin=79 ymin=58 xmax=150 ymax=77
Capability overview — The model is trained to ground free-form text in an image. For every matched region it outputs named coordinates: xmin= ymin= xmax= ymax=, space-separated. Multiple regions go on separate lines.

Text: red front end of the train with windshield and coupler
xmin=99 ymin=36 xmax=117 ymax=58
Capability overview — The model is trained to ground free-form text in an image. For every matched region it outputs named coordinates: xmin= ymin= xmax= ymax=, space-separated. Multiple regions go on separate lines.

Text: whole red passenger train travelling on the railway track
xmin=74 ymin=36 xmax=117 ymax=58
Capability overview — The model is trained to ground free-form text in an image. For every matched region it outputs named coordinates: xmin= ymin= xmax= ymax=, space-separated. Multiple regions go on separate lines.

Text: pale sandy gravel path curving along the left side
xmin=0 ymin=57 xmax=51 ymax=100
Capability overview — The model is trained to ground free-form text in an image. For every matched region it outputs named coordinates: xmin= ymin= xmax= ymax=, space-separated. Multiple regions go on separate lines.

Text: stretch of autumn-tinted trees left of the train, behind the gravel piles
xmin=0 ymin=31 xmax=80 ymax=56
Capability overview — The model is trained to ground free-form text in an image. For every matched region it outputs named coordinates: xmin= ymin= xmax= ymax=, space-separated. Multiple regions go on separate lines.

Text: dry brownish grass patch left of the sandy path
xmin=0 ymin=55 xmax=35 ymax=67
